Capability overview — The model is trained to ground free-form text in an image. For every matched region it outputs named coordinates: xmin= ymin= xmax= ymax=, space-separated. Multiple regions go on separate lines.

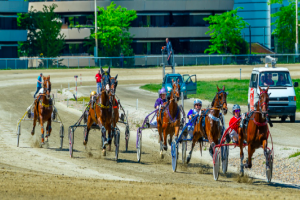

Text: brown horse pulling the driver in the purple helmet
xmin=157 ymin=80 xmax=181 ymax=158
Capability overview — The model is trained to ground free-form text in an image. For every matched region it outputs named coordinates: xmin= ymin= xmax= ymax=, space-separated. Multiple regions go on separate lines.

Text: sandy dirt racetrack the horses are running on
xmin=0 ymin=66 xmax=300 ymax=199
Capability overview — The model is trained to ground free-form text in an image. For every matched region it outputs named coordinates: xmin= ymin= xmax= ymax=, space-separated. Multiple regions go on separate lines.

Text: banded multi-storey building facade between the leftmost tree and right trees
xmin=29 ymin=0 xmax=234 ymax=55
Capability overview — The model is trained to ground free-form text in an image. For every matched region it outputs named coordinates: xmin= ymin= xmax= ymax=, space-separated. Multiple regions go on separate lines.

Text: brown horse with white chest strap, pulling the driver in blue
xmin=187 ymin=86 xmax=228 ymax=163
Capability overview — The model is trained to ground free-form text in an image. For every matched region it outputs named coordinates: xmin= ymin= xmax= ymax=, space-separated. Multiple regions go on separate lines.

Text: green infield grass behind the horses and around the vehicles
xmin=140 ymin=79 xmax=300 ymax=112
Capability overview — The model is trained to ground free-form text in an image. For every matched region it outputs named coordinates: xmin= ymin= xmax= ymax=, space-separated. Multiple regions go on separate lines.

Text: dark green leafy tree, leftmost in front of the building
xmin=18 ymin=4 xmax=65 ymax=57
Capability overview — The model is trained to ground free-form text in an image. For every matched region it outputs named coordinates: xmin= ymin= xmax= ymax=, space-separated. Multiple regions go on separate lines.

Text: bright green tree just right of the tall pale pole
xmin=85 ymin=2 xmax=137 ymax=56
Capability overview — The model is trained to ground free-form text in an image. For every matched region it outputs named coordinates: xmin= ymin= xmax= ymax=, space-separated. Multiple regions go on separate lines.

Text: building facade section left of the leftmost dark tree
xmin=0 ymin=0 xmax=28 ymax=58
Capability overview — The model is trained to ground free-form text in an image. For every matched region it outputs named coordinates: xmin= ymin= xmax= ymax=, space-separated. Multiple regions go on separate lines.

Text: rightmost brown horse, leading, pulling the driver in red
xmin=238 ymin=87 xmax=270 ymax=175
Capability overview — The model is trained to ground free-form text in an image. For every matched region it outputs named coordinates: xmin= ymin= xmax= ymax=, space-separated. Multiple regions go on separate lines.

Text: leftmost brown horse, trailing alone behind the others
xmin=31 ymin=76 xmax=53 ymax=144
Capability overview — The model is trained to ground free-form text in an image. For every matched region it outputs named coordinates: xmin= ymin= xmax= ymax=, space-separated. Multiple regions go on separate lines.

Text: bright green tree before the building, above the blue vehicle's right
xmin=204 ymin=8 xmax=249 ymax=54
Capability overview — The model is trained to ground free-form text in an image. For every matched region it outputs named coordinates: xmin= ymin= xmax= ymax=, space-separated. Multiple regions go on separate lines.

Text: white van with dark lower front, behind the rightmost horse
xmin=248 ymin=67 xmax=298 ymax=122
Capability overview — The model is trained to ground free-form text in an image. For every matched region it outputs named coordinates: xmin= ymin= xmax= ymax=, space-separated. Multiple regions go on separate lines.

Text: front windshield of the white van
xmin=259 ymin=72 xmax=293 ymax=87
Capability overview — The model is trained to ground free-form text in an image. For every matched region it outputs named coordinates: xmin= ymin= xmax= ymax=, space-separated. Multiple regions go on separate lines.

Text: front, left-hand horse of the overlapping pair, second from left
xmin=83 ymin=68 xmax=112 ymax=156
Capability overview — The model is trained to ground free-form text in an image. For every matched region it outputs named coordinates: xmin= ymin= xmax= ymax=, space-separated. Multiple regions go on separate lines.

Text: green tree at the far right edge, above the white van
xmin=271 ymin=1 xmax=296 ymax=53
